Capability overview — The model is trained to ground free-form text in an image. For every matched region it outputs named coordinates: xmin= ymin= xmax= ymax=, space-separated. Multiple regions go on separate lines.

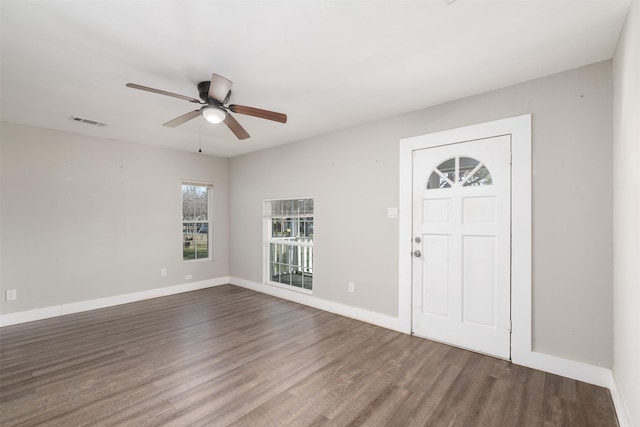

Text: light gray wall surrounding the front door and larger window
xmin=229 ymin=61 xmax=613 ymax=367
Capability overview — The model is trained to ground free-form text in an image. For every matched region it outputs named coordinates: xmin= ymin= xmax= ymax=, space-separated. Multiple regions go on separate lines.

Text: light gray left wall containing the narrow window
xmin=0 ymin=123 xmax=229 ymax=314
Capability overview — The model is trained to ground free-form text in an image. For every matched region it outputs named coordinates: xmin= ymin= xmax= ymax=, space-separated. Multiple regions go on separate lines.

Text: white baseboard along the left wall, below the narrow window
xmin=0 ymin=276 xmax=229 ymax=327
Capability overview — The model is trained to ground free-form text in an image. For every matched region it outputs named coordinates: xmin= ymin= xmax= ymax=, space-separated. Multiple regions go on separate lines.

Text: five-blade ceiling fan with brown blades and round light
xmin=127 ymin=73 xmax=287 ymax=139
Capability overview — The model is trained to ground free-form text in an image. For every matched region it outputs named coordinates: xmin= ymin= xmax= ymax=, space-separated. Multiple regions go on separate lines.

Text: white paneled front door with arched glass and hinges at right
xmin=412 ymin=135 xmax=511 ymax=359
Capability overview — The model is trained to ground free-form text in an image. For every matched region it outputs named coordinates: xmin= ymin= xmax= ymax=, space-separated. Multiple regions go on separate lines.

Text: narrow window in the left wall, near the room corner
xmin=182 ymin=181 xmax=213 ymax=261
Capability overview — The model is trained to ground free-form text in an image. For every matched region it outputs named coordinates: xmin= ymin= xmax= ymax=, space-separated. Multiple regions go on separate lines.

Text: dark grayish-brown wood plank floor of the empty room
xmin=0 ymin=285 xmax=617 ymax=426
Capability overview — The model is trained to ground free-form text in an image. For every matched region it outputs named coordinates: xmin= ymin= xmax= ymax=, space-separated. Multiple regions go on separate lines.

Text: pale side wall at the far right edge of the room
xmin=613 ymin=2 xmax=640 ymax=426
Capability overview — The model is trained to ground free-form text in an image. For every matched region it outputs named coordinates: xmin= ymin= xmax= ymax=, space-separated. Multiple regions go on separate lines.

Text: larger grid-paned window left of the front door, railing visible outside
xmin=264 ymin=198 xmax=313 ymax=291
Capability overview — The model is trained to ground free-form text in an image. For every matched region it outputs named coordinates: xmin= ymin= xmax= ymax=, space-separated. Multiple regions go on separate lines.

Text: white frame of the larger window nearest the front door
xmin=262 ymin=196 xmax=315 ymax=295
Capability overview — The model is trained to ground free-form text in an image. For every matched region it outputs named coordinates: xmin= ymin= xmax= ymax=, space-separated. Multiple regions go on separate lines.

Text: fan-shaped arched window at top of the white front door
xmin=427 ymin=156 xmax=493 ymax=190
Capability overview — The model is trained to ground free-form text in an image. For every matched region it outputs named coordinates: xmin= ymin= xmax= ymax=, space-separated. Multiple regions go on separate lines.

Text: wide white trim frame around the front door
xmin=398 ymin=114 xmax=532 ymax=365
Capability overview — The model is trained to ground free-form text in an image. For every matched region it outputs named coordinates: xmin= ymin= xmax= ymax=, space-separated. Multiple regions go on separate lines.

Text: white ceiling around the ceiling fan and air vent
xmin=0 ymin=0 xmax=630 ymax=157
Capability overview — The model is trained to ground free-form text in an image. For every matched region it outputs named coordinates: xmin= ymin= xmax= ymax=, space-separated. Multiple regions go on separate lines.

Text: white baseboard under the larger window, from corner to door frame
xmin=229 ymin=277 xmax=411 ymax=334
